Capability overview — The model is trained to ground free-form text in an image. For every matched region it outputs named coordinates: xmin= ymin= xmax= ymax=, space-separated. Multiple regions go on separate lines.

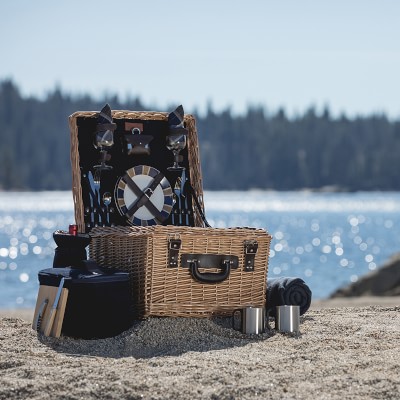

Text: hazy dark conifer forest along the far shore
xmin=0 ymin=80 xmax=400 ymax=191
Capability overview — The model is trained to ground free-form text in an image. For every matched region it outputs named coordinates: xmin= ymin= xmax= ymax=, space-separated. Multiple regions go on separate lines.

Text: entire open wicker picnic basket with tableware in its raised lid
xmin=33 ymin=105 xmax=271 ymax=338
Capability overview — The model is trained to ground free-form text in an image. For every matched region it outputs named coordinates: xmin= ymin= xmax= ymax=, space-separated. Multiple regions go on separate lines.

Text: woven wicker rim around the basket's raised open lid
xmin=69 ymin=110 xmax=204 ymax=232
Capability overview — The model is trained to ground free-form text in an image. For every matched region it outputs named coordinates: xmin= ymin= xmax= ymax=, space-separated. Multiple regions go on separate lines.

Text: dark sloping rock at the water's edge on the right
xmin=330 ymin=253 xmax=400 ymax=298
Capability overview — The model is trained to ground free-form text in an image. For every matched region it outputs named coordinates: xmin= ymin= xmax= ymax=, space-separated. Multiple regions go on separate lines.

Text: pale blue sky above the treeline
xmin=0 ymin=0 xmax=400 ymax=119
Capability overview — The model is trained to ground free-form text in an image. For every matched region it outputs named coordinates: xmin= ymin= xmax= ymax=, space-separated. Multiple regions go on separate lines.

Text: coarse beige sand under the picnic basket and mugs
xmin=0 ymin=298 xmax=400 ymax=399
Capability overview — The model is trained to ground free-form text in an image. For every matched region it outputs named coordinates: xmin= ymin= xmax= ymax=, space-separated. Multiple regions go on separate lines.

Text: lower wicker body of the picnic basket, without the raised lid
xmin=89 ymin=225 xmax=271 ymax=317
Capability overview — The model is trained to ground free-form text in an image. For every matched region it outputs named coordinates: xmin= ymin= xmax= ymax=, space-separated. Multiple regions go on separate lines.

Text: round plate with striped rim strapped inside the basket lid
xmin=115 ymin=165 xmax=173 ymax=226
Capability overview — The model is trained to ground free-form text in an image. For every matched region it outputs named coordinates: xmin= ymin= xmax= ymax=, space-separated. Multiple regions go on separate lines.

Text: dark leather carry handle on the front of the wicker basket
xmin=181 ymin=254 xmax=239 ymax=283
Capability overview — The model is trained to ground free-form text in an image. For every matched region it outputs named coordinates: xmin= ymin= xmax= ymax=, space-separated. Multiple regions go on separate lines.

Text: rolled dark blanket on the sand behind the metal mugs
xmin=267 ymin=277 xmax=311 ymax=317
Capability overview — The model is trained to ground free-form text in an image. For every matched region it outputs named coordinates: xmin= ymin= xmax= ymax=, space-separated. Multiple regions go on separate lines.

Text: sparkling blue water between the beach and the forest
xmin=0 ymin=191 xmax=400 ymax=308
